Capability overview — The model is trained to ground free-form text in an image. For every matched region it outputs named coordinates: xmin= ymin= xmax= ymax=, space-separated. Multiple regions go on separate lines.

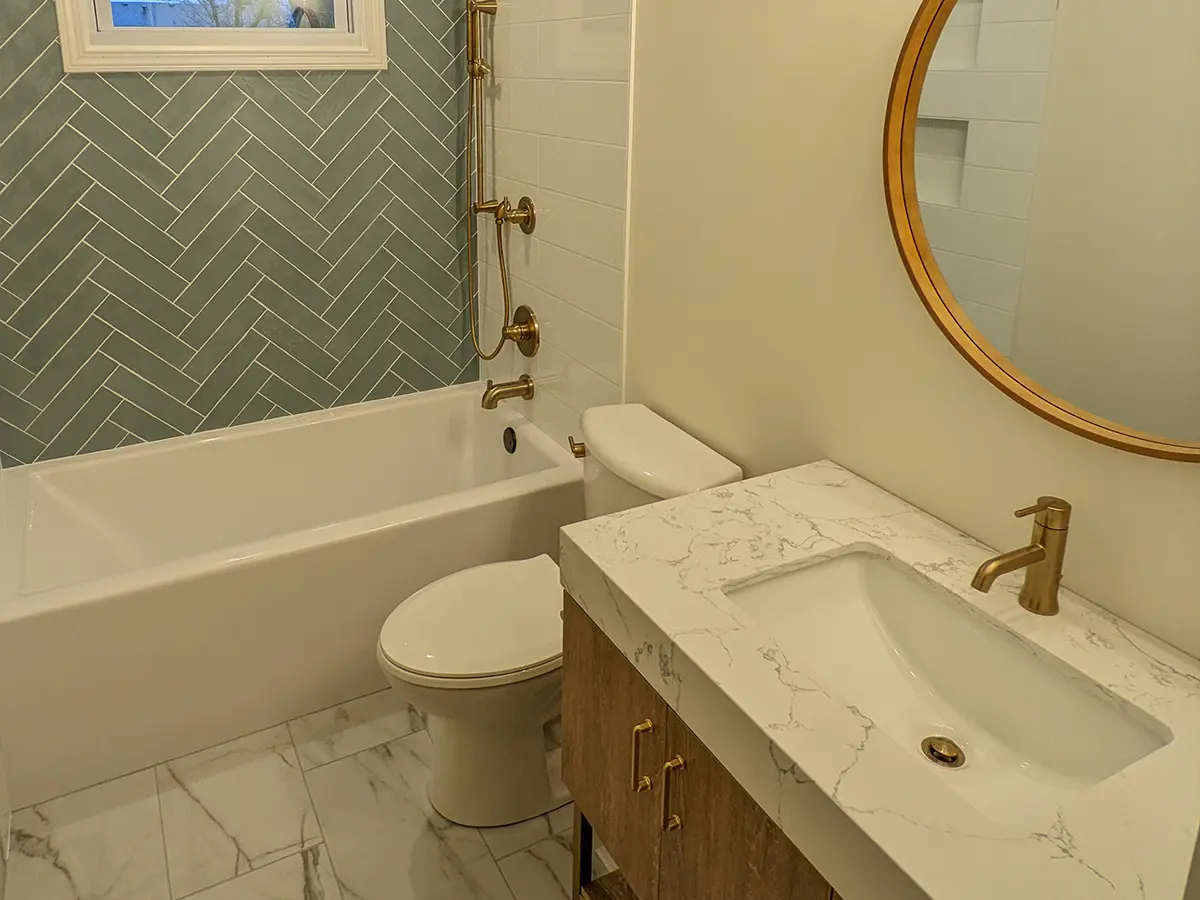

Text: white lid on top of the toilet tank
xmin=583 ymin=403 xmax=743 ymax=499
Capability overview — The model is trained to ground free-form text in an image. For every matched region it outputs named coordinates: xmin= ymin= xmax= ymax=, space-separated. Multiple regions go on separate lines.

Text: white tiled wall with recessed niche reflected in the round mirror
xmin=916 ymin=0 xmax=1057 ymax=354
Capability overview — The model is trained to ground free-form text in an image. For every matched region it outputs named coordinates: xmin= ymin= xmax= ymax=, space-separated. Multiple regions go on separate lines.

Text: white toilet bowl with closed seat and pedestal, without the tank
xmin=377 ymin=556 xmax=570 ymax=827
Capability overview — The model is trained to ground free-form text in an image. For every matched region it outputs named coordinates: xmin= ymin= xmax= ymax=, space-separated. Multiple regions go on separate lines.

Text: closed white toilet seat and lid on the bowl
xmin=378 ymin=556 xmax=563 ymax=689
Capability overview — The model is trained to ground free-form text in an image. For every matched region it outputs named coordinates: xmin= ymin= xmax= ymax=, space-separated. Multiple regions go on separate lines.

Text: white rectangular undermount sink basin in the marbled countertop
xmin=725 ymin=547 xmax=1171 ymax=820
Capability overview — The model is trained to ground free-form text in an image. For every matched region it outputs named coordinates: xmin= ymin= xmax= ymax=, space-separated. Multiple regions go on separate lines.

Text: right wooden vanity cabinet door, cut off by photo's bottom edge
xmin=659 ymin=713 xmax=832 ymax=900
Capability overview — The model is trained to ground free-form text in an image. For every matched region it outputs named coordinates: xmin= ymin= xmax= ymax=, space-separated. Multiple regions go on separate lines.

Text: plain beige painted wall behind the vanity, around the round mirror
xmin=628 ymin=0 xmax=1200 ymax=654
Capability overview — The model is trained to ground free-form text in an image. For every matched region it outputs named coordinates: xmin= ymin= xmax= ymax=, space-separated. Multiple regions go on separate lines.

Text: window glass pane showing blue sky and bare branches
xmin=104 ymin=0 xmax=335 ymax=28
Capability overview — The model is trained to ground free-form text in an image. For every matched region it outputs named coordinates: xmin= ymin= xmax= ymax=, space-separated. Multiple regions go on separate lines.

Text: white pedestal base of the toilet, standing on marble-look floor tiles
xmin=427 ymin=715 xmax=571 ymax=828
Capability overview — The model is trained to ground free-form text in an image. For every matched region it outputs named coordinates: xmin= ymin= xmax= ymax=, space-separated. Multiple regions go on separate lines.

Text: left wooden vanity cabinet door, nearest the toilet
xmin=563 ymin=596 xmax=667 ymax=900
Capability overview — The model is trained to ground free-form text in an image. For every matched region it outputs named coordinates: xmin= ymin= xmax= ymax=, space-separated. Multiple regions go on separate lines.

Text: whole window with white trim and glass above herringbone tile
xmin=56 ymin=0 xmax=388 ymax=72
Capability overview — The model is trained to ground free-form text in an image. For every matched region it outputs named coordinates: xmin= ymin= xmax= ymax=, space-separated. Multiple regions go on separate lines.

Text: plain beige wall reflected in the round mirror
xmin=1013 ymin=0 xmax=1200 ymax=442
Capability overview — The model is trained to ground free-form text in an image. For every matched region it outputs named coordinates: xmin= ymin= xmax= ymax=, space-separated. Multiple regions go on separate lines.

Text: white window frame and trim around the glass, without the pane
xmin=55 ymin=0 xmax=388 ymax=72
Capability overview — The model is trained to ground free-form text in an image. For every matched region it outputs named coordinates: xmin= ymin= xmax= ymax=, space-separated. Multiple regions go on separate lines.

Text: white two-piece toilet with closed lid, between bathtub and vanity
xmin=378 ymin=404 xmax=742 ymax=827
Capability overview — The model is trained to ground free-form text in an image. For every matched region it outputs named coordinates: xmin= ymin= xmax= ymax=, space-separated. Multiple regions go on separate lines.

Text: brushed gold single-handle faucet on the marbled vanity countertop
xmin=971 ymin=497 xmax=1070 ymax=616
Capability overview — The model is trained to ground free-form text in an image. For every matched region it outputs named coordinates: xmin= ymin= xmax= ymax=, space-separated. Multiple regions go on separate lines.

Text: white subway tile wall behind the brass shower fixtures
xmin=480 ymin=0 xmax=631 ymax=440
